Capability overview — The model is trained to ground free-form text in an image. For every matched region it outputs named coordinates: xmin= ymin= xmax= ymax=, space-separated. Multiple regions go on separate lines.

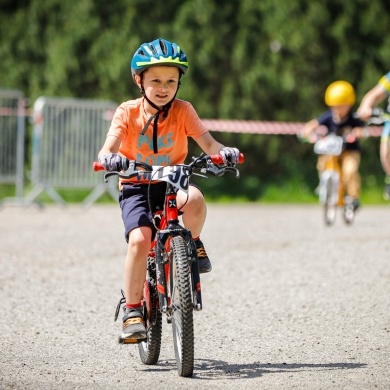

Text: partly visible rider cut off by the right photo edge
xmin=357 ymin=72 xmax=390 ymax=200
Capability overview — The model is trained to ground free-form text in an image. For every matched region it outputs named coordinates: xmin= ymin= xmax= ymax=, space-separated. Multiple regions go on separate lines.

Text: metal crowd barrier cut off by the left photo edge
xmin=0 ymin=89 xmax=25 ymax=198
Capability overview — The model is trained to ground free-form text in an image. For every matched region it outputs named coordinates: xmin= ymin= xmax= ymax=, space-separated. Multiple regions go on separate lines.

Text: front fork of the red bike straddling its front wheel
xmin=156 ymin=225 xmax=202 ymax=314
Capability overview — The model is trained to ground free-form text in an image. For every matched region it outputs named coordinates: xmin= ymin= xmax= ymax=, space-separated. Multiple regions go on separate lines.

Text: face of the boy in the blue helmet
xmin=135 ymin=66 xmax=180 ymax=107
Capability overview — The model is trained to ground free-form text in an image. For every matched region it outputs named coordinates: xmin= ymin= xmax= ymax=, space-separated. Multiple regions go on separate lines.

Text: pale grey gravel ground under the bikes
xmin=0 ymin=205 xmax=390 ymax=389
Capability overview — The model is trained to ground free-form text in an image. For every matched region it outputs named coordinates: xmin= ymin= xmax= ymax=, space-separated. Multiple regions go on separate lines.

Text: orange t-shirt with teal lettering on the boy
xmin=107 ymin=98 xmax=208 ymax=182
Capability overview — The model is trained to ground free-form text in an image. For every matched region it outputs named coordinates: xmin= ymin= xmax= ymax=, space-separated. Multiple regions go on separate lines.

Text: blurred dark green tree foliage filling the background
xmin=0 ymin=0 xmax=390 ymax=200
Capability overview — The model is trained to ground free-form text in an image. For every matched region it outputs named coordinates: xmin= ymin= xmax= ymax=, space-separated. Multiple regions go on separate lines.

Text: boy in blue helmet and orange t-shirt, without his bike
xmin=99 ymin=38 xmax=239 ymax=340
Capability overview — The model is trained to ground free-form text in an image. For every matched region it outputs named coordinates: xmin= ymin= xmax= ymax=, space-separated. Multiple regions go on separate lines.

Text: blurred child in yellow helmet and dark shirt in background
xmin=302 ymin=80 xmax=364 ymax=210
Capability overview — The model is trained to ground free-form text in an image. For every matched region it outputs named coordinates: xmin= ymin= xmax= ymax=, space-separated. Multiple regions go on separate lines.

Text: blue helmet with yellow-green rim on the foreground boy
xmin=130 ymin=38 xmax=188 ymax=78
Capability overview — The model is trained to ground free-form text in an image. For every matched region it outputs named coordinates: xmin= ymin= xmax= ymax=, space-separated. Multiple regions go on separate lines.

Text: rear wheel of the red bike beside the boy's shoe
xmin=138 ymin=257 xmax=162 ymax=365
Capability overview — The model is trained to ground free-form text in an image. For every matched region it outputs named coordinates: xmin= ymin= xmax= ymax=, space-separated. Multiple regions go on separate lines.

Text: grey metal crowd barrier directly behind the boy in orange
xmin=25 ymin=97 xmax=118 ymax=206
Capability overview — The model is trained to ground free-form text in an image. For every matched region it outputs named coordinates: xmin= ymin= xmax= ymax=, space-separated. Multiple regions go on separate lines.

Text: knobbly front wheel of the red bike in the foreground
xmin=169 ymin=236 xmax=194 ymax=377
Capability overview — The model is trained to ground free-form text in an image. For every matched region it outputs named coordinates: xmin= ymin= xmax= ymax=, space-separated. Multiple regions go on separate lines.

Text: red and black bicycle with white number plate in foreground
xmin=94 ymin=154 xmax=244 ymax=377
